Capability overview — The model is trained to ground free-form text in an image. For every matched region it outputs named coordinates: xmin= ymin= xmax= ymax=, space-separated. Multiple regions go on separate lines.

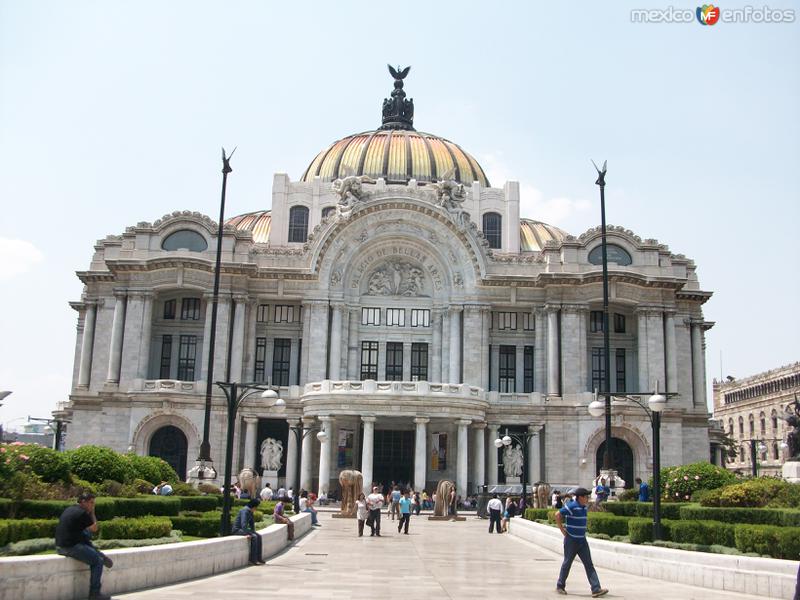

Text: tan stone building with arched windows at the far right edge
xmin=713 ymin=362 xmax=800 ymax=476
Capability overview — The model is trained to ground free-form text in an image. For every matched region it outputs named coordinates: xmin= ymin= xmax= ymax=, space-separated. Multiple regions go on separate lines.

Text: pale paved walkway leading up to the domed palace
xmin=115 ymin=513 xmax=749 ymax=600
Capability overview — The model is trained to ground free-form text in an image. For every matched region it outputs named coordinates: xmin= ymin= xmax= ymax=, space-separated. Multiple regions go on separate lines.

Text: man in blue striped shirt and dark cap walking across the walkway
xmin=556 ymin=488 xmax=608 ymax=598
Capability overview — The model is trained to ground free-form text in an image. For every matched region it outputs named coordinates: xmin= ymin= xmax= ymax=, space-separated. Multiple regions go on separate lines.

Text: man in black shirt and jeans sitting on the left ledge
xmin=56 ymin=492 xmax=114 ymax=600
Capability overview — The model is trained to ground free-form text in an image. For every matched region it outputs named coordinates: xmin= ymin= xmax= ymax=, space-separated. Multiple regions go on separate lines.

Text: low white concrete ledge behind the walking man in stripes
xmin=508 ymin=518 xmax=797 ymax=598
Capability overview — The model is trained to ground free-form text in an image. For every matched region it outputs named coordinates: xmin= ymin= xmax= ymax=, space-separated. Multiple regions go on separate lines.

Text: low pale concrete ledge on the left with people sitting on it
xmin=0 ymin=513 xmax=311 ymax=600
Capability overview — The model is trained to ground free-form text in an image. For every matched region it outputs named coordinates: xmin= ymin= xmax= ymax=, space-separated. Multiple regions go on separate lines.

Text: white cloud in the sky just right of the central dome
xmin=481 ymin=154 xmax=591 ymax=225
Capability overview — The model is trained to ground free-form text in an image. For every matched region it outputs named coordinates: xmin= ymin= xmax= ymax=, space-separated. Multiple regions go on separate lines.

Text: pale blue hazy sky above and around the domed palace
xmin=0 ymin=0 xmax=800 ymax=427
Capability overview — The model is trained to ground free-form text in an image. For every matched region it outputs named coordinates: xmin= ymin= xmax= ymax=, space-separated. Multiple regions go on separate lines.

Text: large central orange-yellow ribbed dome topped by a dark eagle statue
xmin=301 ymin=65 xmax=490 ymax=187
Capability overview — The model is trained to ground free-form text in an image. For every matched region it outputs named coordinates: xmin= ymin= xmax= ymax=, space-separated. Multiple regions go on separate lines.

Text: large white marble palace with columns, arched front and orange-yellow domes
xmin=63 ymin=64 xmax=713 ymax=497
